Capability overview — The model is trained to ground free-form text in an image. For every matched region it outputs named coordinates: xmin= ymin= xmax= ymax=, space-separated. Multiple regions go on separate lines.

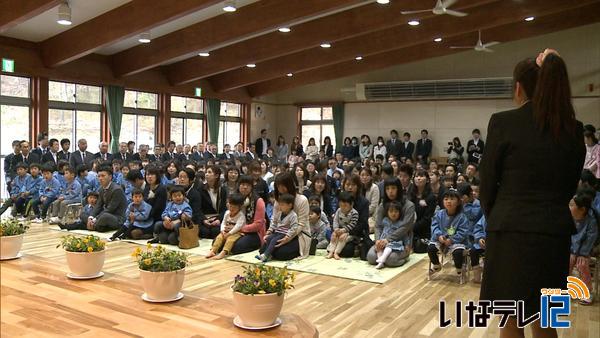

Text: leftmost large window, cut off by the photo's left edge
xmin=0 ymin=75 xmax=31 ymax=198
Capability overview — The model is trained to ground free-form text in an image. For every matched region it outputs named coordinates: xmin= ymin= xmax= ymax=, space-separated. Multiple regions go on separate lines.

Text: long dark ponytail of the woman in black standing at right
xmin=532 ymin=53 xmax=577 ymax=142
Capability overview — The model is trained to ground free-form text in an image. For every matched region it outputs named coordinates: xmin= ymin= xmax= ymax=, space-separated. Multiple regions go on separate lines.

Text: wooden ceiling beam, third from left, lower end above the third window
xmin=113 ymin=0 xmax=365 ymax=76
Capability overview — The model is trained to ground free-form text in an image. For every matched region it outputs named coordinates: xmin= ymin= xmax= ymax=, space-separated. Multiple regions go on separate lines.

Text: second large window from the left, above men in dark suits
xmin=48 ymin=81 xmax=102 ymax=152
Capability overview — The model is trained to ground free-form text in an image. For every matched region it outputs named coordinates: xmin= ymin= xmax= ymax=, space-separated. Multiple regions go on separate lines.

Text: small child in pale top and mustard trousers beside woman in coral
xmin=206 ymin=194 xmax=246 ymax=259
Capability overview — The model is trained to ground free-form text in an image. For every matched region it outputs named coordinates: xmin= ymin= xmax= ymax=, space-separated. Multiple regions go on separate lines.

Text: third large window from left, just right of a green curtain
xmin=119 ymin=90 xmax=158 ymax=149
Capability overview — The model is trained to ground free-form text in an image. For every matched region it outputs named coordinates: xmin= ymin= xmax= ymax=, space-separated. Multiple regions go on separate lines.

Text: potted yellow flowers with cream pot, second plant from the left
xmin=56 ymin=235 xmax=106 ymax=279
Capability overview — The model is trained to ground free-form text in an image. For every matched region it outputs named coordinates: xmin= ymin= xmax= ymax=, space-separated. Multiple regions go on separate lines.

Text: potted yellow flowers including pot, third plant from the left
xmin=132 ymin=244 xmax=189 ymax=303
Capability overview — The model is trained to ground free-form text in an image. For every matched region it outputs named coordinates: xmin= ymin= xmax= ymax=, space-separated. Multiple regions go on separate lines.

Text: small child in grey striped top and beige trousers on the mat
xmin=326 ymin=191 xmax=358 ymax=259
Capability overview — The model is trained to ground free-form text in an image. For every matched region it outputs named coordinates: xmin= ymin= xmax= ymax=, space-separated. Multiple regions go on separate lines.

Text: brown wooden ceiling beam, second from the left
xmin=41 ymin=0 xmax=220 ymax=67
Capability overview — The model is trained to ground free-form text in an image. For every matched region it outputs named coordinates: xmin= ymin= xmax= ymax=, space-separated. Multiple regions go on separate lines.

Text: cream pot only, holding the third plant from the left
xmin=140 ymin=269 xmax=185 ymax=301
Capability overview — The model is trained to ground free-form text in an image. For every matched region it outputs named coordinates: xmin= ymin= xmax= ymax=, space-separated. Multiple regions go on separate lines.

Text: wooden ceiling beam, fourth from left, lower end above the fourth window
xmin=167 ymin=0 xmax=498 ymax=84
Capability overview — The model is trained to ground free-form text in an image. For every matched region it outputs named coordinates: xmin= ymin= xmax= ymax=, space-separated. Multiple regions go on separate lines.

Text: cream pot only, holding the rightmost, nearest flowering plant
xmin=233 ymin=291 xmax=283 ymax=327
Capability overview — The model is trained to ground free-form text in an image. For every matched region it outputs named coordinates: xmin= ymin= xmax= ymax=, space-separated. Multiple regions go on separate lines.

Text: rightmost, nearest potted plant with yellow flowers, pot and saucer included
xmin=231 ymin=264 xmax=295 ymax=329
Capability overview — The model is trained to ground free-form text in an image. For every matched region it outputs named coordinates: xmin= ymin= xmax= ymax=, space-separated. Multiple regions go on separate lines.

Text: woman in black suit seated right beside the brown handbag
xmin=198 ymin=165 xmax=227 ymax=239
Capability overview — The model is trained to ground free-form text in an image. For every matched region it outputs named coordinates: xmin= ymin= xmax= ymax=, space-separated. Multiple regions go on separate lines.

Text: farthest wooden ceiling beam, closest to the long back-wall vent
xmin=246 ymin=2 xmax=600 ymax=97
